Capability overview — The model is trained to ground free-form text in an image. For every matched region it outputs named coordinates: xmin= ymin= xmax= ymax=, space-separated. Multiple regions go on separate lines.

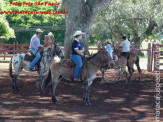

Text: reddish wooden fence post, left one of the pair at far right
xmin=147 ymin=43 xmax=153 ymax=72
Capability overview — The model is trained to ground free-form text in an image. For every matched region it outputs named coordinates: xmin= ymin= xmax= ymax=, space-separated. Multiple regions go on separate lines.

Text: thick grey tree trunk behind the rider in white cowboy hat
xmin=61 ymin=0 xmax=111 ymax=58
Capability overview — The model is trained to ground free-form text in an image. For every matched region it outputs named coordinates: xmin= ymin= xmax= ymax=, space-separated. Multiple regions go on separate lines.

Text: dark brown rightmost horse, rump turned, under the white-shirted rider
xmin=113 ymin=48 xmax=141 ymax=81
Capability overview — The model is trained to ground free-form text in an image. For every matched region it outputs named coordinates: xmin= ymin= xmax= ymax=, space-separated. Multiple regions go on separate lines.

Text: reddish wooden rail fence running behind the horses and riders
xmin=0 ymin=42 xmax=159 ymax=71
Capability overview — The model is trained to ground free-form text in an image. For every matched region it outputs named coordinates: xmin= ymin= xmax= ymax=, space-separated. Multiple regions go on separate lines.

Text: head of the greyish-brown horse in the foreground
xmin=99 ymin=50 xmax=115 ymax=68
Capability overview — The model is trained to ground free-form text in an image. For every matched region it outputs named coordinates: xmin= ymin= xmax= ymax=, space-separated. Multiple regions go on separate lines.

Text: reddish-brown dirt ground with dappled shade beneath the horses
xmin=0 ymin=67 xmax=163 ymax=122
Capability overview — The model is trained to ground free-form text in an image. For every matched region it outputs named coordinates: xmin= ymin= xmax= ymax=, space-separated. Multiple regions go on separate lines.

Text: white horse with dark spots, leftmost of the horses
xmin=9 ymin=43 xmax=64 ymax=94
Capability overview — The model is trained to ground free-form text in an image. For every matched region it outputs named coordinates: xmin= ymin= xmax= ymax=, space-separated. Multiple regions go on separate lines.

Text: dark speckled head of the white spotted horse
xmin=53 ymin=42 xmax=64 ymax=59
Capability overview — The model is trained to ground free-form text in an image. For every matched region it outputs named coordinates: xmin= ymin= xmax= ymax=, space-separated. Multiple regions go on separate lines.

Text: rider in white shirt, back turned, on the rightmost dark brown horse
xmin=120 ymin=36 xmax=131 ymax=56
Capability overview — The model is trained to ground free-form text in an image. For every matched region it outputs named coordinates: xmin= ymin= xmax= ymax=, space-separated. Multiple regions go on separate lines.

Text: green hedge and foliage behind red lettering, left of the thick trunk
xmin=1 ymin=0 xmax=65 ymax=44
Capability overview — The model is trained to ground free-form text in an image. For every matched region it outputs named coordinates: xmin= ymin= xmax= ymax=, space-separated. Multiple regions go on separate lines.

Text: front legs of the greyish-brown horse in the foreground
xmin=83 ymin=80 xmax=93 ymax=106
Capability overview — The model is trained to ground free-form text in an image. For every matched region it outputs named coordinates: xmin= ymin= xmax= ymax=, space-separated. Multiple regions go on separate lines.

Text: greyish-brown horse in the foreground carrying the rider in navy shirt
xmin=45 ymin=50 xmax=114 ymax=106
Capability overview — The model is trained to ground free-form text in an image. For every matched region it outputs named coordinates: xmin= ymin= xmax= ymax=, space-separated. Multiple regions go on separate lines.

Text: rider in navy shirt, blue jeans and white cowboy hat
xmin=70 ymin=30 xmax=88 ymax=81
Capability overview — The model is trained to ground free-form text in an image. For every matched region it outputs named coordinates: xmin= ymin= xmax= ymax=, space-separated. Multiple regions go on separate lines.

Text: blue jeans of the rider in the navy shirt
xmin=71 ymin=54 xmax=83 ymax=79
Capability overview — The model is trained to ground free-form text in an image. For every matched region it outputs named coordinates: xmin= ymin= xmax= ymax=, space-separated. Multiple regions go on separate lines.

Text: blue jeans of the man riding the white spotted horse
xmin=30 ymin=49 xmax=41 ymax=68
